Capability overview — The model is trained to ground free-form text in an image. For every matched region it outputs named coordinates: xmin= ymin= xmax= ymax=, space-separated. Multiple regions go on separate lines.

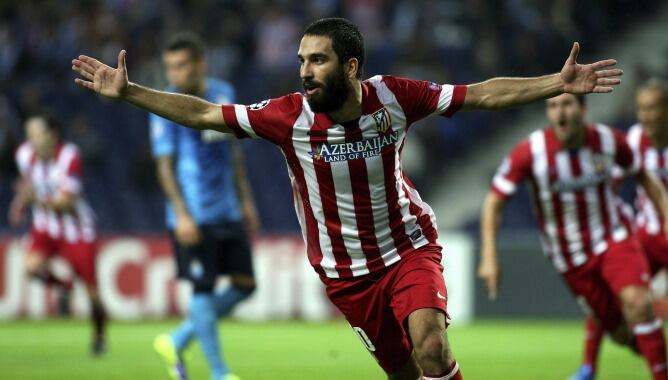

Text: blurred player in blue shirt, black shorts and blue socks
xmin=150 ymin=33 xmax=258 ymax=380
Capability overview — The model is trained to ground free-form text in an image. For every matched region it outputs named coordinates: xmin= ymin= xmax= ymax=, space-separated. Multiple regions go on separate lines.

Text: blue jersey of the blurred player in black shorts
xmin=150 ymin=78 xmax=241 ymax=228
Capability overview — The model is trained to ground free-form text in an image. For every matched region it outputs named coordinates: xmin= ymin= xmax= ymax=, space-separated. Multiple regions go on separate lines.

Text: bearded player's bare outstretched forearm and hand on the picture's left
xmin=72 ymin=50 xmax=231 ymax=133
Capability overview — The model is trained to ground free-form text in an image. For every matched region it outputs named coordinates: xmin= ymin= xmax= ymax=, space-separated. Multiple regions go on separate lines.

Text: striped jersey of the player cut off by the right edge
xmin=626 ymin=124 xmax=668 ymax=235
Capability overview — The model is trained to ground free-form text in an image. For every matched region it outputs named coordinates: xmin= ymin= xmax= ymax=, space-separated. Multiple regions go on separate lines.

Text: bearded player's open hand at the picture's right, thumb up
xmin=560 ymin=42 xmax=624 ymax=94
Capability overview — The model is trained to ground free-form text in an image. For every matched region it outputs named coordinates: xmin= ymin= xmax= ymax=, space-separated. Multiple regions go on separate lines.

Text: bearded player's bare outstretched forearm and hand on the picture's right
xmin=462 ymin=42 xmax=623 ymax=111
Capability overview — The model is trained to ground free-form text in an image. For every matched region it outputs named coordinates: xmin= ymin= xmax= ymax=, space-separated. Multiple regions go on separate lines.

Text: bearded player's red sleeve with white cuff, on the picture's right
xmin=383 ymin=76 xmax=467 ymax=124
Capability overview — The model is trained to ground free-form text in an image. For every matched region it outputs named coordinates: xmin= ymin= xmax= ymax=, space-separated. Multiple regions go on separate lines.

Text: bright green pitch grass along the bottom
xmin=0 ymin=320 xmax=649 ymax=380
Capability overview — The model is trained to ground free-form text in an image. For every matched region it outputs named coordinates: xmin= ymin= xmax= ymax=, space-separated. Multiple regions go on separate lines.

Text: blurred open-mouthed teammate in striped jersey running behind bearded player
xmin=479 ymin=94 xmax=668 ymax=380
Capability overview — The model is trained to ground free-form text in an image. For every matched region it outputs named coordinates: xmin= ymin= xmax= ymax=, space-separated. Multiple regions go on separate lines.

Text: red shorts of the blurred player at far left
xmin=29 ymin=230 xmax=97 ymax=287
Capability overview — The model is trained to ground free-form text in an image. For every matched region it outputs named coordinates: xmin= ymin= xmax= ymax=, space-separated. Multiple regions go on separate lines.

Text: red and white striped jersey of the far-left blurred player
xmin=16 ymin=142 xmax=95 ymax=243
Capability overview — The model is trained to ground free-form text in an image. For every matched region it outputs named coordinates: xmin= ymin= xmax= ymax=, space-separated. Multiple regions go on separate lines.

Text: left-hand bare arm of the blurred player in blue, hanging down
xmin=156 ymin=155 xmax=201 ymax=245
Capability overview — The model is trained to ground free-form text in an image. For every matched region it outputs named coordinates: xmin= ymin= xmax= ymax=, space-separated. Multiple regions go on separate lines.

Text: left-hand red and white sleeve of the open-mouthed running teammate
xmin=491 ymin=141 xmax=531 ymax=199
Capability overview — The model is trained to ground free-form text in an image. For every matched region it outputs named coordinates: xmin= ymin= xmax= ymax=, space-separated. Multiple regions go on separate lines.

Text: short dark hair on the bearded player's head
xmin=304 ymin=17 xmax=365 ymax=79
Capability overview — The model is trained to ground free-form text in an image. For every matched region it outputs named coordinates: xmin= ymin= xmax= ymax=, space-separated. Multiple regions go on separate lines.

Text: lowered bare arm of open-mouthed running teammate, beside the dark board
xmin=478 ymin=191 xmax=506 ymax=300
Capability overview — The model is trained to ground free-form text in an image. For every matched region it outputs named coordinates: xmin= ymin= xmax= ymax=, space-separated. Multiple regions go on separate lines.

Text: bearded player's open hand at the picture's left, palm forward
xmin=72 ymin=50 xmax=129 ymax=99
